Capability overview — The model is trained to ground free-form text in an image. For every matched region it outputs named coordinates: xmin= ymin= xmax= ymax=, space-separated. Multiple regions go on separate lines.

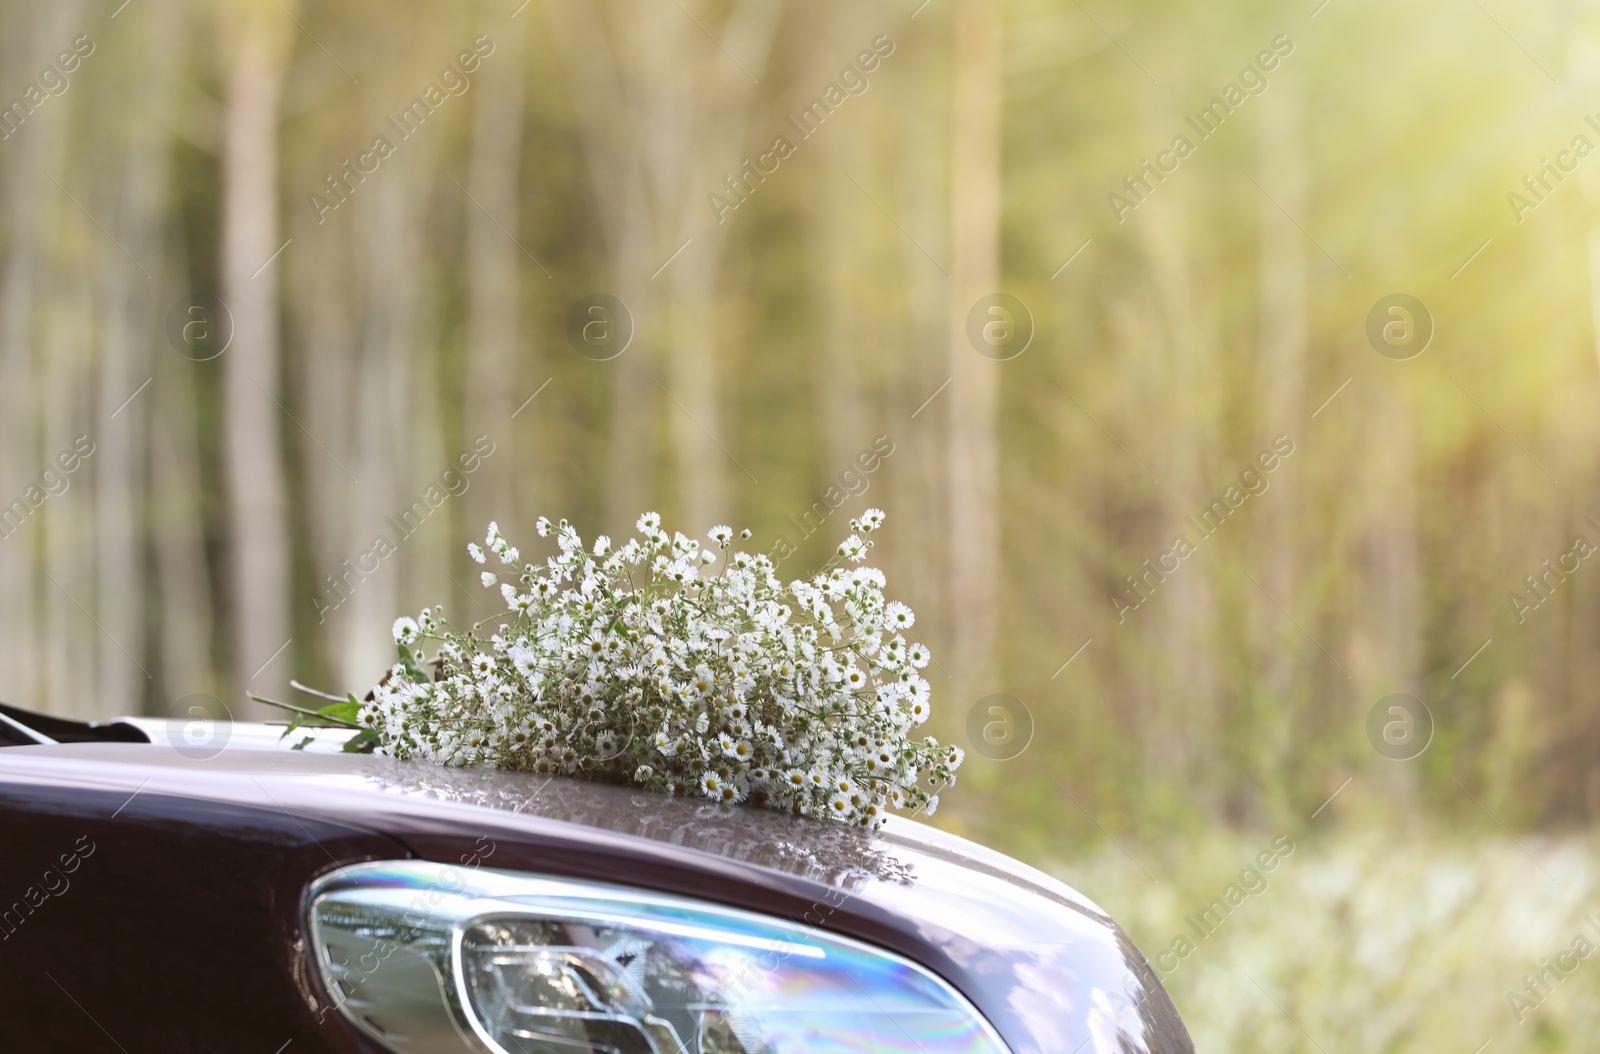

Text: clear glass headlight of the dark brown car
xmin=307 ymin=860 xmax=1006 ymax=1054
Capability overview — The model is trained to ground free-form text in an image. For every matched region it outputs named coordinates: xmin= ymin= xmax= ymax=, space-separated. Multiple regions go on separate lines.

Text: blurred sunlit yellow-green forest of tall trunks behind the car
xmin=0 ymin=0 xmax=1600 ymax=1054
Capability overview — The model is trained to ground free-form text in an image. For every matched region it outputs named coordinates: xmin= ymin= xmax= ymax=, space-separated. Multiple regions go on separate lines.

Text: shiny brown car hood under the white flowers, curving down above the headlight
xmin=0 ymin=742 xmax=1194 ymax=1054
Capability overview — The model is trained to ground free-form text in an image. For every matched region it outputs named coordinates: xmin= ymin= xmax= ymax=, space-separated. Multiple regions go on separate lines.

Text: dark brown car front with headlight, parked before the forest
xmin=0 ymin=707 xmax=1194 ymax=1054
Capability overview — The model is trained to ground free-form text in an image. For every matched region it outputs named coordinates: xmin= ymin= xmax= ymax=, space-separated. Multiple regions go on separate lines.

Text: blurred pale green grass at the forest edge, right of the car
xmin=1050 ymin=827 xmax=1600 ymax=1054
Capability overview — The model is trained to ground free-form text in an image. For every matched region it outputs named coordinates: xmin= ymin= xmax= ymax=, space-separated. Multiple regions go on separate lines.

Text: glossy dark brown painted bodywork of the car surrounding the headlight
xmin=0 ymin=736 xmax=1194 ymax=1054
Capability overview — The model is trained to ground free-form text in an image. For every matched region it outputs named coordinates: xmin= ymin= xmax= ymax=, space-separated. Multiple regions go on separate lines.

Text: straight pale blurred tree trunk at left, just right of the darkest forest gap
xmin=221 ymin=5 xmax=294 ymax=717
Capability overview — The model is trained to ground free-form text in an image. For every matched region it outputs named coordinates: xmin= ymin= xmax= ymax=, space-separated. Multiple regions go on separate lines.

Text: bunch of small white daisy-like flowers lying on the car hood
xmin=358 ymin=509 xmax=962 ymax=827
